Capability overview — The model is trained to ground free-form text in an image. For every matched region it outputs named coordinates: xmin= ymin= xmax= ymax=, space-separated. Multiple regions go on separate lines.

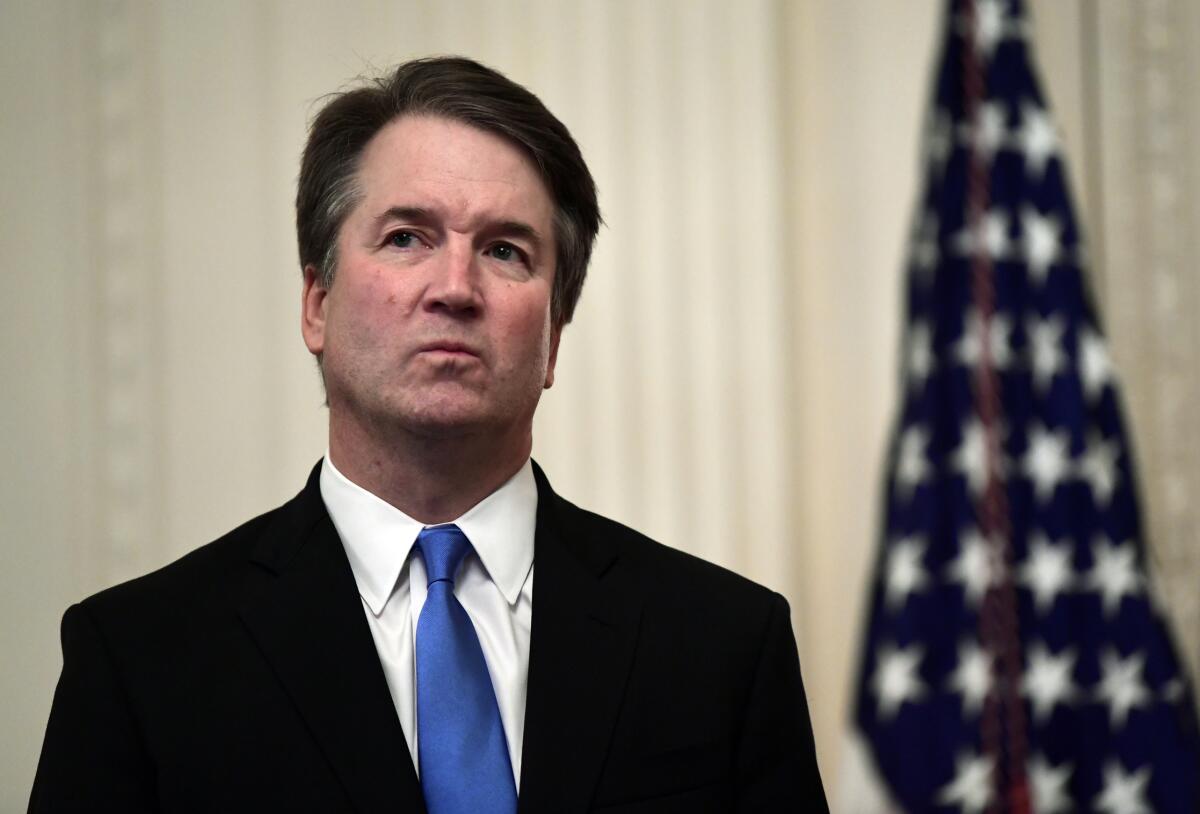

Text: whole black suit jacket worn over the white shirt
xmin=30 ymin=465 xmax=827 ymax=814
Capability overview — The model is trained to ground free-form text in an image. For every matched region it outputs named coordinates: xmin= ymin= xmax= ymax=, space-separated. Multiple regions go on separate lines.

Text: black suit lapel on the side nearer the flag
xmin=518 ymin=466 xmax=642 ymax=814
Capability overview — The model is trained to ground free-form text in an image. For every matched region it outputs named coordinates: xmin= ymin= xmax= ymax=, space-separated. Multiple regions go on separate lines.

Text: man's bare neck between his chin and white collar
xmin=329 ymin=421 xmax=533 ymax=525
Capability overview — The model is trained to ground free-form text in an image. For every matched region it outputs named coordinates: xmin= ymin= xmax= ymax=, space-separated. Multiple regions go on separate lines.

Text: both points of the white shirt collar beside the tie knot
xmin=320 ymin=451 xmax=538 ymax=616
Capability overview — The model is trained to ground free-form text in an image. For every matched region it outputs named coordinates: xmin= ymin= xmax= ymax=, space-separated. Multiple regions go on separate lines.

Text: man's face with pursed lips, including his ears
xmin=302 ymin=116 xmax=559 ymax=437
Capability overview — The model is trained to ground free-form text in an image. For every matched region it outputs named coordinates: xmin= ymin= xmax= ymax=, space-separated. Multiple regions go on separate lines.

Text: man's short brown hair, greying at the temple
xmin=296 ymin=56 xmax=601 ymax=327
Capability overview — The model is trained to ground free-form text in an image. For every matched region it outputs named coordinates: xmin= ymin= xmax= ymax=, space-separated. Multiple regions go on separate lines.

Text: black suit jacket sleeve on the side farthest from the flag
xmin=29 ymin=605 xmax=157 ymax=814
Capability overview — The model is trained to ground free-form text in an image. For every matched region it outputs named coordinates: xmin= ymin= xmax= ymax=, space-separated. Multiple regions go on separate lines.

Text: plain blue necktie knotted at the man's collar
xmin=416 ymin=526 xmax=517 ymax=814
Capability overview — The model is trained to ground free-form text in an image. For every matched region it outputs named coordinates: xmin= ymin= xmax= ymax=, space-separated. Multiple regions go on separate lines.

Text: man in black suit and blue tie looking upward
xmin=30 ymin=59 xmax=826 ymax=814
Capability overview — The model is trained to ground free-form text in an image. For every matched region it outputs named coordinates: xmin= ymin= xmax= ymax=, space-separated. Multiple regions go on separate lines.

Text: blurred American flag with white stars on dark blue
xmin=854 ymin=0 xmax=1200 ymax=814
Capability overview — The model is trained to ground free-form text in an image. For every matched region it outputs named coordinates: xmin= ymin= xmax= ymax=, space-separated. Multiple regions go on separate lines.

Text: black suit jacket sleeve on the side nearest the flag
xmin=737 ymin=594 xmax=829 ymax=813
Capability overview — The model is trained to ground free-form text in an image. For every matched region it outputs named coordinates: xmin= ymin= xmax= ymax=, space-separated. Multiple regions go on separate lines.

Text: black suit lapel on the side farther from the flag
xmin=240 ymin=465 xmax=425 ymax=813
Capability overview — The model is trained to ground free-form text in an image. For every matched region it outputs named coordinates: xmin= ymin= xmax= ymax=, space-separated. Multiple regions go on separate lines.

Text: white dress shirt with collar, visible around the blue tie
xmin=320 ymin=453 xmax=538 ymax=790
